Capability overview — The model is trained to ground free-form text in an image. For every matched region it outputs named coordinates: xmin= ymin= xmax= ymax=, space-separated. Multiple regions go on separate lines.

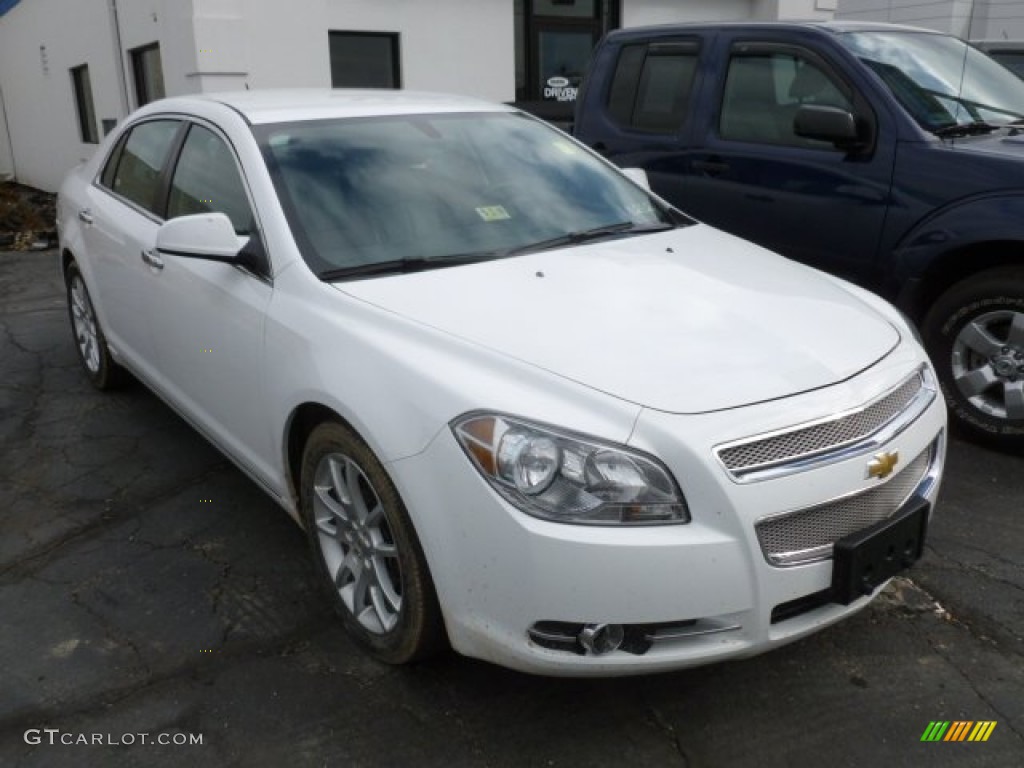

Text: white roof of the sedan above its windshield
xmin=152 ymin=88 xmax=514 ymax=125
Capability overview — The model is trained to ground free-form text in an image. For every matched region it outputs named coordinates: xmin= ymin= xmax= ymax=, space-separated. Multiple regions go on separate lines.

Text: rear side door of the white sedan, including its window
xmin=78 ymin=119 xmax=182 ymax=380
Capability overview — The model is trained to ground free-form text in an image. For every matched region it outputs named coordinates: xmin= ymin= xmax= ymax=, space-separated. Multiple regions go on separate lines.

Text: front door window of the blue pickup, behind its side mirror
xmin=719 ymin=52 xmax=853 ymax=150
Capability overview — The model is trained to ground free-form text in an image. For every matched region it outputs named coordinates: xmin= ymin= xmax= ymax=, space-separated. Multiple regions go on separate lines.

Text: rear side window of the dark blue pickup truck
xmin=607 ymin=42 xmax=698 ymax=133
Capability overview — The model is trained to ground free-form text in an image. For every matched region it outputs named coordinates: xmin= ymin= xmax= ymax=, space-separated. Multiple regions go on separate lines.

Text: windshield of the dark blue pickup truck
xmin=840 ymin=32 xmax=1024 ymax=131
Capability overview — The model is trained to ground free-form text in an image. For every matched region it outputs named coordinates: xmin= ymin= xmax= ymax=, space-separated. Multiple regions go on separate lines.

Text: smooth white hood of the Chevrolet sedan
xmin=336 ymin=224 xmax=899 ymax=413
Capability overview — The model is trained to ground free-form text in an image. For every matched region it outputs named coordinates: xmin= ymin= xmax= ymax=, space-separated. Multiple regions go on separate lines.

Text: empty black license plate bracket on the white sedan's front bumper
xmin=831 ymin=497 xmax=931 ymax=605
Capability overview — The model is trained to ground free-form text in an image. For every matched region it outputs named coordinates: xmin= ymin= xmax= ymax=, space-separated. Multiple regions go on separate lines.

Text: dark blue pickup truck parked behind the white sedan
xmin=574 ymin=23 xmax=1024 ymax=451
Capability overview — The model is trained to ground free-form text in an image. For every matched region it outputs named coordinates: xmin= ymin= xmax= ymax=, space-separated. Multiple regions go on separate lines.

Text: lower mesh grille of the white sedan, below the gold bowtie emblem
xmin=755 ymin=445 xmax=936 ymax=565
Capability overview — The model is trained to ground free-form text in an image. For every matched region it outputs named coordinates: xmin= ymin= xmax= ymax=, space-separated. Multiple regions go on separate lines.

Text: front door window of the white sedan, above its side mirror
xmin=167 ymin=125 xmax=253 ymax=234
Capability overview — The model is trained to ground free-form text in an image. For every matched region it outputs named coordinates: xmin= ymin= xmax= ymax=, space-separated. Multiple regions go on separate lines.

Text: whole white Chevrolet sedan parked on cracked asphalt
xmin=58 ymin=91 xmax=946 ymax=675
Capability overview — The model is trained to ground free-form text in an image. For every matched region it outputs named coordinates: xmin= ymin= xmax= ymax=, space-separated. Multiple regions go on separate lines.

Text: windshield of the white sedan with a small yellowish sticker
xmin=253 ymin=113 xmax=675 ymax=279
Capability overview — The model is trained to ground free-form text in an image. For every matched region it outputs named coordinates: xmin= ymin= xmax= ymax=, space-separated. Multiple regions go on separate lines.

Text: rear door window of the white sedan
xmin=109 ymin=120 xmax=179 ymax=215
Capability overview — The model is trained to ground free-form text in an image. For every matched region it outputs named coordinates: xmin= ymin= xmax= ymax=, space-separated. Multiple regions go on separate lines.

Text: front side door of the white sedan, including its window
xmin=152 ymin=123 xmax=272 ymax=479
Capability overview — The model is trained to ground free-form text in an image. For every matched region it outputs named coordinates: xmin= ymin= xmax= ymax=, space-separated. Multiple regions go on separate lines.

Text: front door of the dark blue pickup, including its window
xmin=675 ymin=35 xmax=895 ymax=283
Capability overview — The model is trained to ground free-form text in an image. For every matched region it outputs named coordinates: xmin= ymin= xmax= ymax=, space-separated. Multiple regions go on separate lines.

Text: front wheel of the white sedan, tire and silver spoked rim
xmin=301 ymin=422 xmax=444 ymax=664
